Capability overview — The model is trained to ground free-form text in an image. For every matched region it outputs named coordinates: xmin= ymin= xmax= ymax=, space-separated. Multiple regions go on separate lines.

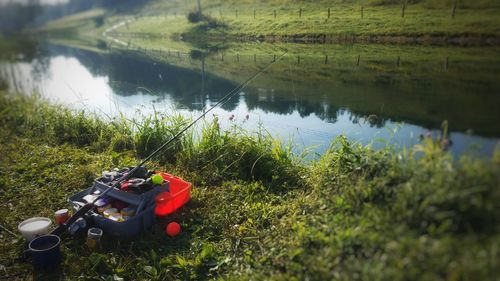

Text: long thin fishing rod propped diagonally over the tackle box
xmin=51 ymin=52 xmax=286 ymax=236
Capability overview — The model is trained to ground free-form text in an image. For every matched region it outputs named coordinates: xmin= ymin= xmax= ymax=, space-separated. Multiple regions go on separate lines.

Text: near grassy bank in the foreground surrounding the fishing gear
xmin=0 ymin=93 xmax=500 ymax=280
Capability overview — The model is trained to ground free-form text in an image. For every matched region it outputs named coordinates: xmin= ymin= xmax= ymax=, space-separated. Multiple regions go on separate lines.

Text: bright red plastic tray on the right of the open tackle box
xmin=155 ymin=172 xmax=191 ymax=216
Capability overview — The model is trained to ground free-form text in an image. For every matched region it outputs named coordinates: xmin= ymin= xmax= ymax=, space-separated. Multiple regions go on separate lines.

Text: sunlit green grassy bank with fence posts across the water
xmin=109 ymin=1 xmax=500 ymax=44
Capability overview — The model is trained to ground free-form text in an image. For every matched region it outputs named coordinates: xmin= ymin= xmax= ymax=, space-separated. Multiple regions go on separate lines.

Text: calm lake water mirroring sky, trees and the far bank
xmin=0 ymin=40 xmax=500 ymax=156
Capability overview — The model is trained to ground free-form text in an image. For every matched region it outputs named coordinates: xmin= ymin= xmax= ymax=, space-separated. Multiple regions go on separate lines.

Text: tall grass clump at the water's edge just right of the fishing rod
xmin=179 ymin=118 xmax=303 ymax=187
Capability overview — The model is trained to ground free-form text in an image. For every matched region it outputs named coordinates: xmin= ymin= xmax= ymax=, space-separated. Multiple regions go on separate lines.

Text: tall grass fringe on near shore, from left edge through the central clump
xmin=0 ymin=94 xmax=303 ymax=186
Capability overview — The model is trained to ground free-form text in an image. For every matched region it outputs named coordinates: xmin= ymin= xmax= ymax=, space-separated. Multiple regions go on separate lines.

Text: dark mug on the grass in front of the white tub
xmin=24 ymin=234 xmax=61 ymax=269
